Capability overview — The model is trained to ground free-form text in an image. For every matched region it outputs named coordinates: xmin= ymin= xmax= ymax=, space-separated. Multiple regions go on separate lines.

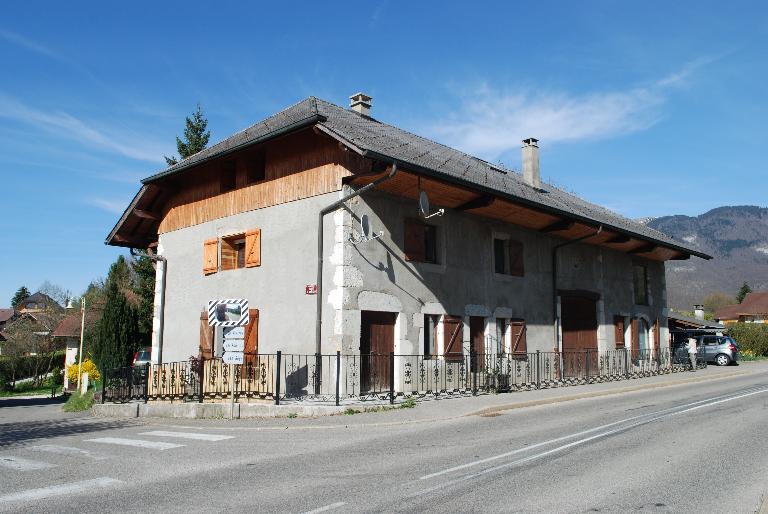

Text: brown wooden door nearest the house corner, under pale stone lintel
xmin=360 ymin=311 xmax=397 ymax=393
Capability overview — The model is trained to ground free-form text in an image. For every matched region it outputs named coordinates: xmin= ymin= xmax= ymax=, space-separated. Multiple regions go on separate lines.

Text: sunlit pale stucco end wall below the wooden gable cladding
xmin=159 ymin=192 xmax=340 ymax=362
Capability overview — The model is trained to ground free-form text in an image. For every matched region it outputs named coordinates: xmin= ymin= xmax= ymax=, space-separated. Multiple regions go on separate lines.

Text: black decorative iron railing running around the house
xmin=102 ymin=349 xmax=703 ymax=405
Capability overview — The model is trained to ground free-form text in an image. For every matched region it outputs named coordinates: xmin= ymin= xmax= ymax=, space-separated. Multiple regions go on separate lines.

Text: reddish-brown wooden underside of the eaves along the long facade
xmin=351 ymin=170 xmax=680 ymax=261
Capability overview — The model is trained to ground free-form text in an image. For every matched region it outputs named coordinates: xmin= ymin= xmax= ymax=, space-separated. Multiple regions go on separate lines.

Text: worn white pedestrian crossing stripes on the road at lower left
xmin=0 ymin=430 xmax=234 ymax=504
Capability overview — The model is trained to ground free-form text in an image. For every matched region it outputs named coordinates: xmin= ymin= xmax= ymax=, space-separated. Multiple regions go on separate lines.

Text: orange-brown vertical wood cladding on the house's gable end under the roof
xmin=157 ymin=130 xmax=364 ymax=234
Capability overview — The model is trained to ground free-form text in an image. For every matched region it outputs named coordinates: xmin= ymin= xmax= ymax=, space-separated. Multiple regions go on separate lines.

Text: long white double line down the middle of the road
xmin=416 ymin=388 xmax=768 ymax=482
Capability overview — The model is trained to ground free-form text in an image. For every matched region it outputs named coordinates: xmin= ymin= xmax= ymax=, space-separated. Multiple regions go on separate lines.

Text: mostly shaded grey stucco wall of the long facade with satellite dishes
xmin=334 ymin=193 xmax=666 ymax=353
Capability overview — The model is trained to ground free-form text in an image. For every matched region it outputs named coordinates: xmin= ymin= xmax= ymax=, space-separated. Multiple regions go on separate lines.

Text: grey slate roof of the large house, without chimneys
xmin=142 ymin=97 xmax=711 ymax=259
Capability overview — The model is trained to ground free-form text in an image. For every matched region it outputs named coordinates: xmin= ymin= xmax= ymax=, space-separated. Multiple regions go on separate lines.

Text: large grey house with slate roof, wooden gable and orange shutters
xmin=106 ymin=94 xmax=711 ymax=380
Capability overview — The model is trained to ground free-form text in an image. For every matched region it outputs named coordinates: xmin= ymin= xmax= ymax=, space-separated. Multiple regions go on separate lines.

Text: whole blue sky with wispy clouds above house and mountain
xmin=0 ymin=1 xmax=768 ymax=307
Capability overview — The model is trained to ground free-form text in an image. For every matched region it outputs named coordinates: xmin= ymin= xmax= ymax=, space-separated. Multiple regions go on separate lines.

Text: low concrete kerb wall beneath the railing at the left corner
xmin=91 ymin=403 xmax=345 ymax=419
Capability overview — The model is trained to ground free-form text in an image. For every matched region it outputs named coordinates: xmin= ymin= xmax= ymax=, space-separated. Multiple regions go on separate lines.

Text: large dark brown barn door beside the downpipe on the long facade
xmin=560 ymin=296 xmax=598 ymax=377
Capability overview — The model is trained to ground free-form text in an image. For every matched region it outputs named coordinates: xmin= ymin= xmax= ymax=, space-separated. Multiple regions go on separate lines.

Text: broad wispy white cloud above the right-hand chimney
xmin=427 ymin=59 xmax=711 ymax=159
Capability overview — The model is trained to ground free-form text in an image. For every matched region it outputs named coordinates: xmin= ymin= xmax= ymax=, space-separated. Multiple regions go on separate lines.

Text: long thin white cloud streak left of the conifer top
xmin=0 ymin=93 xmax=168 ymax=162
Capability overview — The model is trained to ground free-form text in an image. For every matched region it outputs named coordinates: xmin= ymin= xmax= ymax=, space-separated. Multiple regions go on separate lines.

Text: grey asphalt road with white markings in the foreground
xmin=0 ymin=366 xmax=768 ymax=513
